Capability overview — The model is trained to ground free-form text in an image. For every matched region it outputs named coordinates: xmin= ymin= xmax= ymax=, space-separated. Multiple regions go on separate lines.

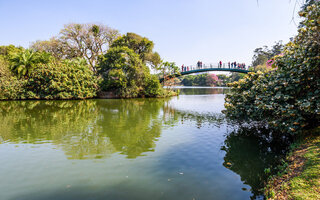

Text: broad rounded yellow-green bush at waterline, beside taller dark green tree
xmin=26 ymin=59 xmax=98 ymax=99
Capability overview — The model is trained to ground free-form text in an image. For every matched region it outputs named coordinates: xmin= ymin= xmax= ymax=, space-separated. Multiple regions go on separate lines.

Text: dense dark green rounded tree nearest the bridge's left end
xmin=98 ymin=46 xmax=161 ymax=98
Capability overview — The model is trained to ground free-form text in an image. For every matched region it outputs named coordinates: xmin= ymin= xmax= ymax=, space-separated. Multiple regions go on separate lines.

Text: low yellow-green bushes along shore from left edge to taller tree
xmin=0 ymin=57 xmax=98 ymax=100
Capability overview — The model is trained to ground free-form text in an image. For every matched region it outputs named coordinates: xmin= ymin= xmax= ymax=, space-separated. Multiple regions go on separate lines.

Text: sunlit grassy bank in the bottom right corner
xmin=265 ymin=127 xmax=320 ymax=199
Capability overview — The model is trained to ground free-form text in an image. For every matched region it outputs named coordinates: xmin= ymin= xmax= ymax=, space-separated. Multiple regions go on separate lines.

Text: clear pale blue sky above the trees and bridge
xmin=0 ymin=0 xmax=299 ymax=65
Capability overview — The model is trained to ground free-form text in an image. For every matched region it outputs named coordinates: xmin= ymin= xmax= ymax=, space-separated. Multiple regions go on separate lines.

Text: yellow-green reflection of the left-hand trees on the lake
xmin=0 ymin=99 xmax=170 ymax=159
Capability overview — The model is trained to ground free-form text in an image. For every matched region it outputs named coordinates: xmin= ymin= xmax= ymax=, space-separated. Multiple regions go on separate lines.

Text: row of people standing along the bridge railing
xmin=181 ymin=60 xmax=246 ymax=72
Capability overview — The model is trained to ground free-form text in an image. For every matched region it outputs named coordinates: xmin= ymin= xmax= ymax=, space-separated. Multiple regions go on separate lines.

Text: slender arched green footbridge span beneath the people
xmin=160 ymin=67 xmax=249 ymax=83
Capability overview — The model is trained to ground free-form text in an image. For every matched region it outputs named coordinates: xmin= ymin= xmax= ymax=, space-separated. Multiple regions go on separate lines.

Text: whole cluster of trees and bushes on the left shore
xmin=0 ymin=24 xmax=175 ymax=100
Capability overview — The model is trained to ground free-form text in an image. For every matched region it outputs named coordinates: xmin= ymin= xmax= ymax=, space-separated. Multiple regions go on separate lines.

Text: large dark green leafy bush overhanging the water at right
xmin=224 ymin=2 xmax=320 ymax=134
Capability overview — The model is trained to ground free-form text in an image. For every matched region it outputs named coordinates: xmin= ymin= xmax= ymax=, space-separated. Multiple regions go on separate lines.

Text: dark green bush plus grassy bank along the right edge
xmin=224 ymin=0 xmax=320 ymax=199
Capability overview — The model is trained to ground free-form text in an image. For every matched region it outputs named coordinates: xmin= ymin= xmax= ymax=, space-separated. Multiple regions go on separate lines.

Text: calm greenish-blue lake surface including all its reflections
xmin=0 ymin=88 xmax=286 ymax=200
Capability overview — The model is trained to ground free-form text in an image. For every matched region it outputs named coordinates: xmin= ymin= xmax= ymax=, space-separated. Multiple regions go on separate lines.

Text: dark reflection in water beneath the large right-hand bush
xmin=221 ymin=126 xmax=292 ymax=199
